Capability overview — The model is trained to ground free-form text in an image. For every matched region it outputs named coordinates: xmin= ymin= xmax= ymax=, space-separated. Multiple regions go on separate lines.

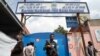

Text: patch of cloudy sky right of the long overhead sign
xmin=81 ymin=0 xmax=100 ymax=19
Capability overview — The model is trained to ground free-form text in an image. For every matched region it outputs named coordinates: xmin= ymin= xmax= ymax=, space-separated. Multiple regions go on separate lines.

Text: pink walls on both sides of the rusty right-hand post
xmin=67 ymin=20 xmax=100 ymax=56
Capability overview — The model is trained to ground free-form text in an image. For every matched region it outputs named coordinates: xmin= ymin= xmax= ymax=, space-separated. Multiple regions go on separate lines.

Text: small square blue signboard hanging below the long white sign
xmin=66 ymin=16 xmax=78 ymax=27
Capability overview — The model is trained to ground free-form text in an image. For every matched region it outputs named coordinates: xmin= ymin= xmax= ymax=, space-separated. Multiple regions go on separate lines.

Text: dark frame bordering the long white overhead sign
xmin=15 ymin=1 xmax=90 ymax=14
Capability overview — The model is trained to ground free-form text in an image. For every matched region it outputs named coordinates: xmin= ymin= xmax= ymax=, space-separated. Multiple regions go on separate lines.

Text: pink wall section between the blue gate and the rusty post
xmin=67 ymin=32 xmax=84 ymax=56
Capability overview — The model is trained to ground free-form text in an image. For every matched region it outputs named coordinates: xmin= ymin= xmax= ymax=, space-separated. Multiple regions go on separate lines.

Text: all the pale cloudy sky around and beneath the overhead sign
xmin=6 ymin=0 xmax=100 ymax=33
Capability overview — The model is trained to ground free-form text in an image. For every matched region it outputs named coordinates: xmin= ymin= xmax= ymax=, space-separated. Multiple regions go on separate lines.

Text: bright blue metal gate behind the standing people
xmin=23 ymin=33 xmax=69 ymax=56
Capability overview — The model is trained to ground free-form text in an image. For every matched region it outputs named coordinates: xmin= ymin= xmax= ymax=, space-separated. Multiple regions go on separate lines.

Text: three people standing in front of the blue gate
xmin=11 ymin=34 xmax=58 ymax=56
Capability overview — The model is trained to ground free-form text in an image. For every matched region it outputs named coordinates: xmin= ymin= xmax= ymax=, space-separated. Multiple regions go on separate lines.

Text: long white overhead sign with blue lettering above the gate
xmin=16 ymin=2 xmax=89 ymax=14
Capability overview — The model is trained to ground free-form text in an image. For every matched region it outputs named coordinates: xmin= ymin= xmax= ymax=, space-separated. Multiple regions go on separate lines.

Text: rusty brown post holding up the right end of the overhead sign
xmin=77 ymin=13 xmax=87 ymax=56
